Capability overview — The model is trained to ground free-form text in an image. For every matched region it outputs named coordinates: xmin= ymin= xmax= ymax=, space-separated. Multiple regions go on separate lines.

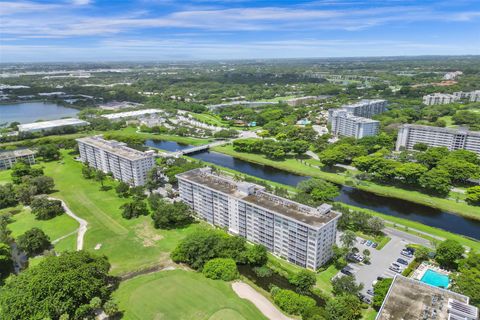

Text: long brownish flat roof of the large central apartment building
xmin=177 ymin=168 xmax=340 ymax=228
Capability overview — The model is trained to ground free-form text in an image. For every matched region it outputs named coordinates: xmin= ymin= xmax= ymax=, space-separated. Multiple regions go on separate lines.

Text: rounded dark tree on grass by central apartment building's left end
xmin=152 ymin=200 xmax=193 ymax=229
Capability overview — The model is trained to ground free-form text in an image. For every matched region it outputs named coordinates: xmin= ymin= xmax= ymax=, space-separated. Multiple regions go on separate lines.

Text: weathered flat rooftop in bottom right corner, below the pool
xmin=376 ymin=275 xmax=478 ymax=320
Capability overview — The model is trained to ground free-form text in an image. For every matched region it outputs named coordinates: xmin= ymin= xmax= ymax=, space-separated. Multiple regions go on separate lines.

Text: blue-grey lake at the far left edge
xmin=0 ymin=102 xmax=78 ymax=124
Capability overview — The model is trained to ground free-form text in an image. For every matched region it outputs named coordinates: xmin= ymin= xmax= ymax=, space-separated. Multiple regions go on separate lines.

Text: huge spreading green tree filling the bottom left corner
xmin=0 ymin=251 xmax=111 ymax=320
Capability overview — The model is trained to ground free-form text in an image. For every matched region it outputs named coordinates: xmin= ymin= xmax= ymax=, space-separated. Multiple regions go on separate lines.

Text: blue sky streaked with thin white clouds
xmin=0 ymin=0 xmax=480 ymax=62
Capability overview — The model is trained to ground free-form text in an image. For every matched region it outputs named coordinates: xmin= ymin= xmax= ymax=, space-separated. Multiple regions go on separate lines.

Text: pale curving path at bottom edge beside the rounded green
xmin=232 ymin=281 xmax=293 ymax=320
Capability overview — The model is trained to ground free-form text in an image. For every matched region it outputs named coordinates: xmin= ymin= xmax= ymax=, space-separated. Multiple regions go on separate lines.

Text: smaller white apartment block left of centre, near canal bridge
xmin=77 ymin=136 xmax=155 ymax=186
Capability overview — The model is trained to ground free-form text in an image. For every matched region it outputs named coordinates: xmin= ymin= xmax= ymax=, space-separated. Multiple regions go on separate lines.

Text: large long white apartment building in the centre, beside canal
xmin=177 ymin=168 xmax=340 ymax=270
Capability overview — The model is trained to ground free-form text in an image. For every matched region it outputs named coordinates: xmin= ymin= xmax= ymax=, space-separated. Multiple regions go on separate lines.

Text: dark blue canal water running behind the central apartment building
xmin=146 ymin=140 xmax=480 ymax=240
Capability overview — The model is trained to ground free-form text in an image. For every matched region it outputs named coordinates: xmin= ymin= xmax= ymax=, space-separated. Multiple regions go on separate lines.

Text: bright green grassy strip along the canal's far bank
xmin=213 ymin=145 xmax=480 ymax=220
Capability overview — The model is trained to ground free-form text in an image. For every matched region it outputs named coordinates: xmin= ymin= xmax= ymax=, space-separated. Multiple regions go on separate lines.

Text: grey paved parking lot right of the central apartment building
xmin=336 ymin=231 xmax=413 ymax=299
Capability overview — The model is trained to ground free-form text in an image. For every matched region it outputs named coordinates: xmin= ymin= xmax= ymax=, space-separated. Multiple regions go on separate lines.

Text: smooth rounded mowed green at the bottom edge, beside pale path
xmin=113 ymin=270 xmax=266 ymax=320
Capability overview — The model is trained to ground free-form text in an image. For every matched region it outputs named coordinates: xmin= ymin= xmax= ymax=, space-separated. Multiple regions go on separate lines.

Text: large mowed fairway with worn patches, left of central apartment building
xmin=38 ymin=151 xmax=201 ymax=275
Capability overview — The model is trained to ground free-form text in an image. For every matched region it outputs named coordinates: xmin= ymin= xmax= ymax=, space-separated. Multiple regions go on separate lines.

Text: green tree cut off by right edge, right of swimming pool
xmin=452 ymin=252 xmax=480 ymax=306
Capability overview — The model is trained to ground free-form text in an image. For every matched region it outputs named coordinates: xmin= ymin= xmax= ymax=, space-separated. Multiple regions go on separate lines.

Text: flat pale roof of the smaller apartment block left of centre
xmin=76 ymin=136 xmax=154 ymax=161
